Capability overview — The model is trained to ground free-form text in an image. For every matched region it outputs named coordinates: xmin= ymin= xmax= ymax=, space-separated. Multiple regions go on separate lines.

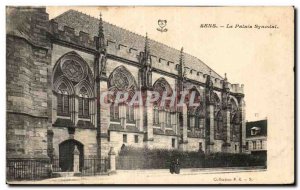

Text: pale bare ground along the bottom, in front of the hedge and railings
xmin=11 ymin=168 xmax=266 ymax=184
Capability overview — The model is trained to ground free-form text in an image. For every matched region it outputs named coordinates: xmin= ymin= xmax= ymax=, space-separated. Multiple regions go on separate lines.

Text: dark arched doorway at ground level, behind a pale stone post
xmin=59 ymin=139 xmax=84 ymax=172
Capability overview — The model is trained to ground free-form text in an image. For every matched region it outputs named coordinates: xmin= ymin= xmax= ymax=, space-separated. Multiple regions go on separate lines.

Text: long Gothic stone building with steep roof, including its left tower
xmin=6 ymin=7 xmax=246 ymax=171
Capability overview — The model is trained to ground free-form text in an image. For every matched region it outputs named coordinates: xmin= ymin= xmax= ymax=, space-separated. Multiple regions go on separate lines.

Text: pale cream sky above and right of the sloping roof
xmin=47 ymin=7 xmax=294 ymax=121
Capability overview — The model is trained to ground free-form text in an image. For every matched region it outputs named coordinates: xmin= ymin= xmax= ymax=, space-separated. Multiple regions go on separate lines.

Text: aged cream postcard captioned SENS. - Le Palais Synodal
xmin=6 ymin=6 xmax=295 ymax=185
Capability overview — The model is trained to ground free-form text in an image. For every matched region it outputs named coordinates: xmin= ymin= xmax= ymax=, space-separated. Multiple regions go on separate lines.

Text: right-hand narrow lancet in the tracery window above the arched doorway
xmin=78 ymin=87 xmax=90 ymax=119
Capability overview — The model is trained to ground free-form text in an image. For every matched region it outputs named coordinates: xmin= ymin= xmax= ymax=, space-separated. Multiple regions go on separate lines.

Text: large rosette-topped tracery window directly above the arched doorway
xmin=52 ymin=52 xmax=96 ymax=127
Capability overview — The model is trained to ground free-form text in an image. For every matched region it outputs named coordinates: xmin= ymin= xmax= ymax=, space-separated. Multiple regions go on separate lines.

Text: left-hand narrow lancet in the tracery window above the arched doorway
xmin=57 ymin=83 xmax=70 ymax=116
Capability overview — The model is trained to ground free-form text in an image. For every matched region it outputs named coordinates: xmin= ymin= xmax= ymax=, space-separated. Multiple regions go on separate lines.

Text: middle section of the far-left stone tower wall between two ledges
xmin=6 ymin=36 xmax=49 ymax=117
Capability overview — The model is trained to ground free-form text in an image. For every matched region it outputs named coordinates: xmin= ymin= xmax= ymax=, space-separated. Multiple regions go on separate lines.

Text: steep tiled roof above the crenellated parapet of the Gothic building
xmin=53 ymin=10 xmax=223 ymax=80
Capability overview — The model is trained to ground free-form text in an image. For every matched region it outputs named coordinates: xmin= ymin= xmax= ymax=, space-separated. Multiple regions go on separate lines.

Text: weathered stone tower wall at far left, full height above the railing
xmin=6 ymin=7 xmax=51 ymax=157
